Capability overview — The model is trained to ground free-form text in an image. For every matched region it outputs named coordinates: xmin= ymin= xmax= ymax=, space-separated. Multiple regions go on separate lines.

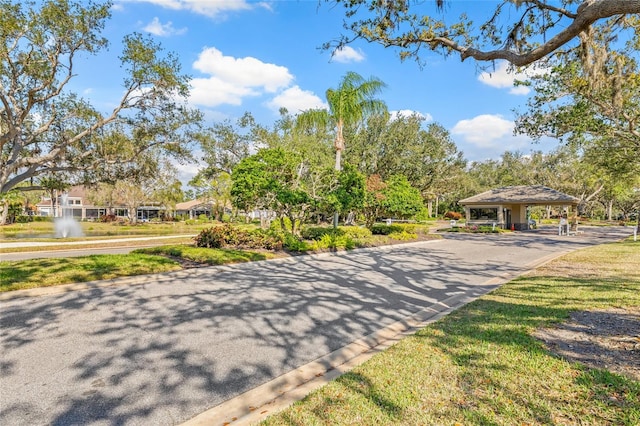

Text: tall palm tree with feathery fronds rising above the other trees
xmin=298 ymin=71 xmax=387 ymax=170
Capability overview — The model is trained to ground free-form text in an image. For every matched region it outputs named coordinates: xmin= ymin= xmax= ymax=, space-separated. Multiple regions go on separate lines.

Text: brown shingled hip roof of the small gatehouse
xmin=459 ymin=185 xmax=580 ymax=205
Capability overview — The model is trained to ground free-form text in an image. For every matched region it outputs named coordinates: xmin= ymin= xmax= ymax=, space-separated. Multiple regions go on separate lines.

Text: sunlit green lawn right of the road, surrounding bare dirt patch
xmin=264 ymin=241 xmax=640 ymax=425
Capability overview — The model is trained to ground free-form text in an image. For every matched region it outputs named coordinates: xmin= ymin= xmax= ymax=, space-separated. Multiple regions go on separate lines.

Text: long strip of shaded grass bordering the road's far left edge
xmin=0 ymin=245 xmax=273 ymax=291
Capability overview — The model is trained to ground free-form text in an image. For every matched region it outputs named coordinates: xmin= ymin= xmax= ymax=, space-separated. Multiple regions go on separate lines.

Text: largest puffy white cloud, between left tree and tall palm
xmin=191 ymin=47 xmax=293 ymax=107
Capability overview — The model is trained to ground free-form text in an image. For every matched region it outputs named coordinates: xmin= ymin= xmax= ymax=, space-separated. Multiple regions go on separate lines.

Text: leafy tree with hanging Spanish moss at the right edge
xmin=516 ymin=16 xmax=640 ymax=179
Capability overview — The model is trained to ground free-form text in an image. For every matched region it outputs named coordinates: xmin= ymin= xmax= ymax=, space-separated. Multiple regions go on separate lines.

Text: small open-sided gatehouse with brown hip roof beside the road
xmin=459 ymin=185 xmax=580 ymax=231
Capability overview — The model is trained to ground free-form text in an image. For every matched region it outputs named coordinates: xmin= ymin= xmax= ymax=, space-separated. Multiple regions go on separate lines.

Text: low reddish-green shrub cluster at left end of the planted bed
xmin=194 ymin=224 xmax=283 ymax=250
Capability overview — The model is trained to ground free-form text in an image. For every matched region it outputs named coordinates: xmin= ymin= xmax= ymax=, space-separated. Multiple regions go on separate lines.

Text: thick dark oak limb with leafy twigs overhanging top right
xmin=325 ymin=0 xmax=640 ymax=66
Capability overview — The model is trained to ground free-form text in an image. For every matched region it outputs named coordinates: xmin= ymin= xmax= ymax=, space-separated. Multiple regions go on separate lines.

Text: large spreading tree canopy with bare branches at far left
xmin=0 ymin=0 xmax=200 ymax=193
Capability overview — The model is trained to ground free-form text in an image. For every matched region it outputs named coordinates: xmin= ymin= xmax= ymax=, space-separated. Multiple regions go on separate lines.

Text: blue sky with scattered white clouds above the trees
xmin=70 ymin=0 xmax=554 ymax=179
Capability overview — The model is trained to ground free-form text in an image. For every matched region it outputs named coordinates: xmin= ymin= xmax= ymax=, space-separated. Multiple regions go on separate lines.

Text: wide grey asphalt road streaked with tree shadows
xmin=0 ymin=228 xmax=631 ymax=425
